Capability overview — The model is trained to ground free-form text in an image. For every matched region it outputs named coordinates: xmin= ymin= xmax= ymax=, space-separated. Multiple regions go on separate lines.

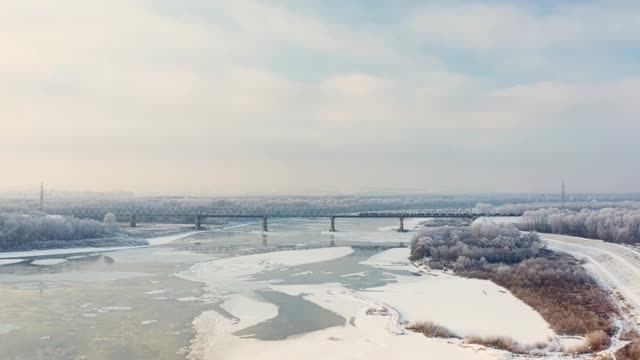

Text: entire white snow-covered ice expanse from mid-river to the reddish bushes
xmin=179 ymin=243 xmax=554 ymax=360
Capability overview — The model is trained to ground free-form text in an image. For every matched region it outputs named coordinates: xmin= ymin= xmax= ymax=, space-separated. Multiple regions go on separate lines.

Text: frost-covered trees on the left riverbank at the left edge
xmin=0 ymin=212 xmax=147 ymax=251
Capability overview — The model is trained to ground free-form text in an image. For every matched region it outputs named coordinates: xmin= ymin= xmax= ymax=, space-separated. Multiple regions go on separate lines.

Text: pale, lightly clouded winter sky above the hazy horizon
xmin=0 ymin=0 xmax=640 ymax=195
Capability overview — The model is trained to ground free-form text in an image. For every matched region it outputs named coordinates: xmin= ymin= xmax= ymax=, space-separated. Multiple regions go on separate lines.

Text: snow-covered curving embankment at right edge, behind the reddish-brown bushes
xmin=539 ymin=234 xmax=640 ymax=316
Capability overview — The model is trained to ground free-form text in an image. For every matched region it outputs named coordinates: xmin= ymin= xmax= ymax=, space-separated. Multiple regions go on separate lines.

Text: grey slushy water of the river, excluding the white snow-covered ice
xmin=0 ymin=219 xmax=420 ymax=360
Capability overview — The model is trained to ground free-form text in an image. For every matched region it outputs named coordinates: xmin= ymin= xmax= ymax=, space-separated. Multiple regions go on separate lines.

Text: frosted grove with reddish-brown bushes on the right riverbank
xmin=411 ymin=223 xmax=617 ymax=344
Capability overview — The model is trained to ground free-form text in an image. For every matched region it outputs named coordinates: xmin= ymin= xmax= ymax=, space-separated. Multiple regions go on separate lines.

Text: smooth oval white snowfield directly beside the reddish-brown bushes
xmin=359 ymin=274 xmax=555 ymax=344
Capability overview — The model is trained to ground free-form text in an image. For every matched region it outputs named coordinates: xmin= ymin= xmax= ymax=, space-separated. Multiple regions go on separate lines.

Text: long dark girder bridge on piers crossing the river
xmin=47 ymin=207 xmax=522 ymax=232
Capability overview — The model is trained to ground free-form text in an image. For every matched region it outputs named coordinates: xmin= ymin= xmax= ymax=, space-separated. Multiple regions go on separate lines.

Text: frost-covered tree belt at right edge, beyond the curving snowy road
xmin=519 ymin=208 xmax=640 ymax=243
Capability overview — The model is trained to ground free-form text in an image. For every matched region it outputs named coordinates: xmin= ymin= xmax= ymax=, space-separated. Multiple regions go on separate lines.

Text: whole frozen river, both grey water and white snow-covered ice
xmin=0 ymin=219 xmax=555 ymax=360
